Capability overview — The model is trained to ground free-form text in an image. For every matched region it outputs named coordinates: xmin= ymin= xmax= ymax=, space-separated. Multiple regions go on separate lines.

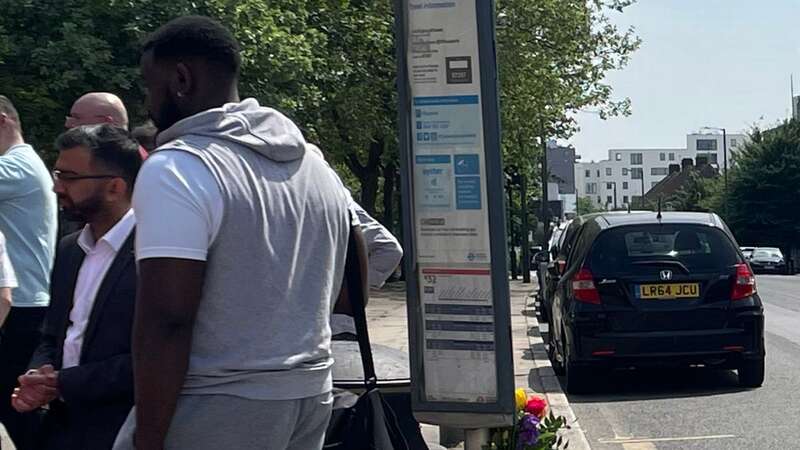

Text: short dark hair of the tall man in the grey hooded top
xmin=142 ymin=16 xmax=242 ymax=77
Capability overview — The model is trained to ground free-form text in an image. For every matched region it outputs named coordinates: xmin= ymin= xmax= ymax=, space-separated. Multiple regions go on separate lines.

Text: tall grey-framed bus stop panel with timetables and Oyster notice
xmin=396 ymin=0 xmax=514 ymax=427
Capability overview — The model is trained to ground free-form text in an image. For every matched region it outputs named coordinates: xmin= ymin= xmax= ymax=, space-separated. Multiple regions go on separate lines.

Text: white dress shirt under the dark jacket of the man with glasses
xmin=61 ymin=209 xmax=136 ymax=369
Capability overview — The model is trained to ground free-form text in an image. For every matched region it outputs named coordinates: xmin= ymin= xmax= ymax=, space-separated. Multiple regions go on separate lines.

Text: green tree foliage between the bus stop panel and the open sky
xmin=497 ymin=0 xmax=640 ymax=179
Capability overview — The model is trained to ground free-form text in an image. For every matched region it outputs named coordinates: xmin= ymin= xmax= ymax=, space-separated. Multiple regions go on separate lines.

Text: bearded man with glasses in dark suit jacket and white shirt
xmin=11 ymin=125 xmax=142 ymax=450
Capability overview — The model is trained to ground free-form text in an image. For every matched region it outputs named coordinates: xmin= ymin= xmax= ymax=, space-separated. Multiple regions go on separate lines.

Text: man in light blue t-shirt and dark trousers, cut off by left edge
xmin=0 ymin=95 xmax=57 ymax=449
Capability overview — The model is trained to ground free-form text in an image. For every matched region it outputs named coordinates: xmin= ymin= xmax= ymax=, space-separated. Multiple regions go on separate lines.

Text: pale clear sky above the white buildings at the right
xmin=568 ymin=0 xmax=800 ymax=161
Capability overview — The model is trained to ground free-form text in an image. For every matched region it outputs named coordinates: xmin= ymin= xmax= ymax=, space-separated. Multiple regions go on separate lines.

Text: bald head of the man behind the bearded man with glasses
xmin=64 ymin=92 xmax=147 ymax=160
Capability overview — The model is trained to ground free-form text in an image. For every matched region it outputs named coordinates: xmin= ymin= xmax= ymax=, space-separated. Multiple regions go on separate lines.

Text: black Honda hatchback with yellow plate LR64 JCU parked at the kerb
xmin=549 ymin=212 xmax=765 ymax=393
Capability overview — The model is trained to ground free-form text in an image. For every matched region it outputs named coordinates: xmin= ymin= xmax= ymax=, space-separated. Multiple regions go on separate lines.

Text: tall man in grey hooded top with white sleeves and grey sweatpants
xmin=115 ymin=16 xmax=349 ymax=450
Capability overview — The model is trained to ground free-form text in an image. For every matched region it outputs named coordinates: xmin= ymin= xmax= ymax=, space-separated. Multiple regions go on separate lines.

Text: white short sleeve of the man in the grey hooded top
xmin=133 ymin=150 xmax=223 ymax=261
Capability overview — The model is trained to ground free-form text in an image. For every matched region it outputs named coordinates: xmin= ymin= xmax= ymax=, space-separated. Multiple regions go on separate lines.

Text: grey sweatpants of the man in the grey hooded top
xmin=114 ymin=393 xmax=333 ymax=450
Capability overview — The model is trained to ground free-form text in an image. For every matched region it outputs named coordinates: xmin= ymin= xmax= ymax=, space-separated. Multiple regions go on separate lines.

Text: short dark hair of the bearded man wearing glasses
xmin=55 ymin=124 xmax=142 ymax=190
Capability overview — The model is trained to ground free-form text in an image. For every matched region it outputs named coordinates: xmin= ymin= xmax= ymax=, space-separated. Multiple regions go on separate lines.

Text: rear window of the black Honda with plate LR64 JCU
xmin=589 ymin=224 xmax=739 ymax=275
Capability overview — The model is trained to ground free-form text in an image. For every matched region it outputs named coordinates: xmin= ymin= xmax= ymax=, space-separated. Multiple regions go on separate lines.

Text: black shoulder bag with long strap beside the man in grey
xmin=323 ymin=218 xmax=409 ymax=450
